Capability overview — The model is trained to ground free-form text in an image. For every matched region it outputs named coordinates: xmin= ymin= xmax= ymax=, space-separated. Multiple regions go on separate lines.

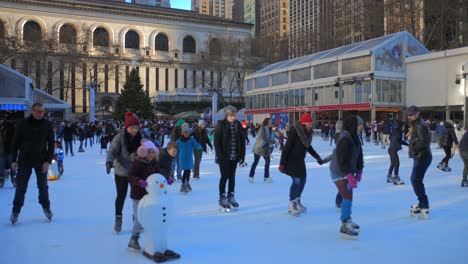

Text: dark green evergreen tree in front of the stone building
xmin=114 ymin=69 xmax=153 ymax=120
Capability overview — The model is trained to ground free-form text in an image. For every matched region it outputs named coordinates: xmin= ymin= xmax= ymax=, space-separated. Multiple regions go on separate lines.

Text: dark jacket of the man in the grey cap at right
xmin=408 ymin=117 xmax=432 ymax=159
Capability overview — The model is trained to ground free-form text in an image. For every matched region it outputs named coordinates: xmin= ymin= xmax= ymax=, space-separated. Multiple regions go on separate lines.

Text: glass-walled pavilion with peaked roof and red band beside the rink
xmin=244 ymin=31 xmax=429 ymax=124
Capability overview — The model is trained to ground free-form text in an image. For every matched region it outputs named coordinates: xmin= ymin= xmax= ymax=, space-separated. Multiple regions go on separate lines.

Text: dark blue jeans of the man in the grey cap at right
xmin=411 ymin=153 xmax=432 ymax=208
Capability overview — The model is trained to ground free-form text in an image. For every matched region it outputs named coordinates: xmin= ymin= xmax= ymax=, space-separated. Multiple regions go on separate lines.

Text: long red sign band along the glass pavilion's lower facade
xmin=245 ymin=103 xmax=372 ymax=114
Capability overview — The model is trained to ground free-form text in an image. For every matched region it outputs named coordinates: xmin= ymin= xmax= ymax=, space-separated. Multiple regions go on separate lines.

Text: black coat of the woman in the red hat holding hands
xmin=280 ymin=124 xmax=321 ymax=178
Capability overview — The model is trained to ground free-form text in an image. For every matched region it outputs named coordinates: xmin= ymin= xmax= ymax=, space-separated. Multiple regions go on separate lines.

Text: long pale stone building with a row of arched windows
xmin=0 ymin=0 xmax=250 ymax=117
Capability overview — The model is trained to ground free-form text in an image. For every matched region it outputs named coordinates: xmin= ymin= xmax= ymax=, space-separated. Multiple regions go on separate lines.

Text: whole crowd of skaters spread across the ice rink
xmin=0 ymin=104 xmax=468 ymax=243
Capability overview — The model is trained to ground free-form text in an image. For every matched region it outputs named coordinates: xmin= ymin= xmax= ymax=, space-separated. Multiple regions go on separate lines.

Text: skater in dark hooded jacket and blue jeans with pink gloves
xmin=330 ymin=115 xmax=364 ymax=239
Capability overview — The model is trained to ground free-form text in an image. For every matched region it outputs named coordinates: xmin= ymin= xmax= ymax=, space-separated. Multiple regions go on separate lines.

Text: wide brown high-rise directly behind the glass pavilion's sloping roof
xmin=289 ymin=0 xmax=384 ymax=58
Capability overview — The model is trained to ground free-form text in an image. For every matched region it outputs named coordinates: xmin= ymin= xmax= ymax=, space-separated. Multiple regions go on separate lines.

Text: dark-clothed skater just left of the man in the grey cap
xmin=387 ymin=120 xmax=408 ymax=185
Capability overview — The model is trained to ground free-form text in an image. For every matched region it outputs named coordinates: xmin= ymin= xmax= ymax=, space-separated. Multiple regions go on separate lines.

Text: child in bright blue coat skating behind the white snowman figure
xmin=176 ymin=126 xmax=203 ymax=193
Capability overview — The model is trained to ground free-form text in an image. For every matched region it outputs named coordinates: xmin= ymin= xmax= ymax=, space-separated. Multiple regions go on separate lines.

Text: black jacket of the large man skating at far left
xmin=11 ymin=115 xmax=55 ymax=167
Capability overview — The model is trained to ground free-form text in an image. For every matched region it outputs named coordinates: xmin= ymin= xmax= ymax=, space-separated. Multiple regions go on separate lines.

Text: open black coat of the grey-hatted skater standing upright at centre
xmin=213 ymin=119 xmax=245 ymax=163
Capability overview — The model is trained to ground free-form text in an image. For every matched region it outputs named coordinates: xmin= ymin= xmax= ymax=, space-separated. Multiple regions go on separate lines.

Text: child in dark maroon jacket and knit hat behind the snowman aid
xmin=128 ymin=139 xmax=160 ymax=250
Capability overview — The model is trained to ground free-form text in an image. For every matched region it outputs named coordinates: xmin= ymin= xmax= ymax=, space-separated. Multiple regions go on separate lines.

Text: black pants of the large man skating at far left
xmin=13 ymin=165 xmax=50 ymax=213
